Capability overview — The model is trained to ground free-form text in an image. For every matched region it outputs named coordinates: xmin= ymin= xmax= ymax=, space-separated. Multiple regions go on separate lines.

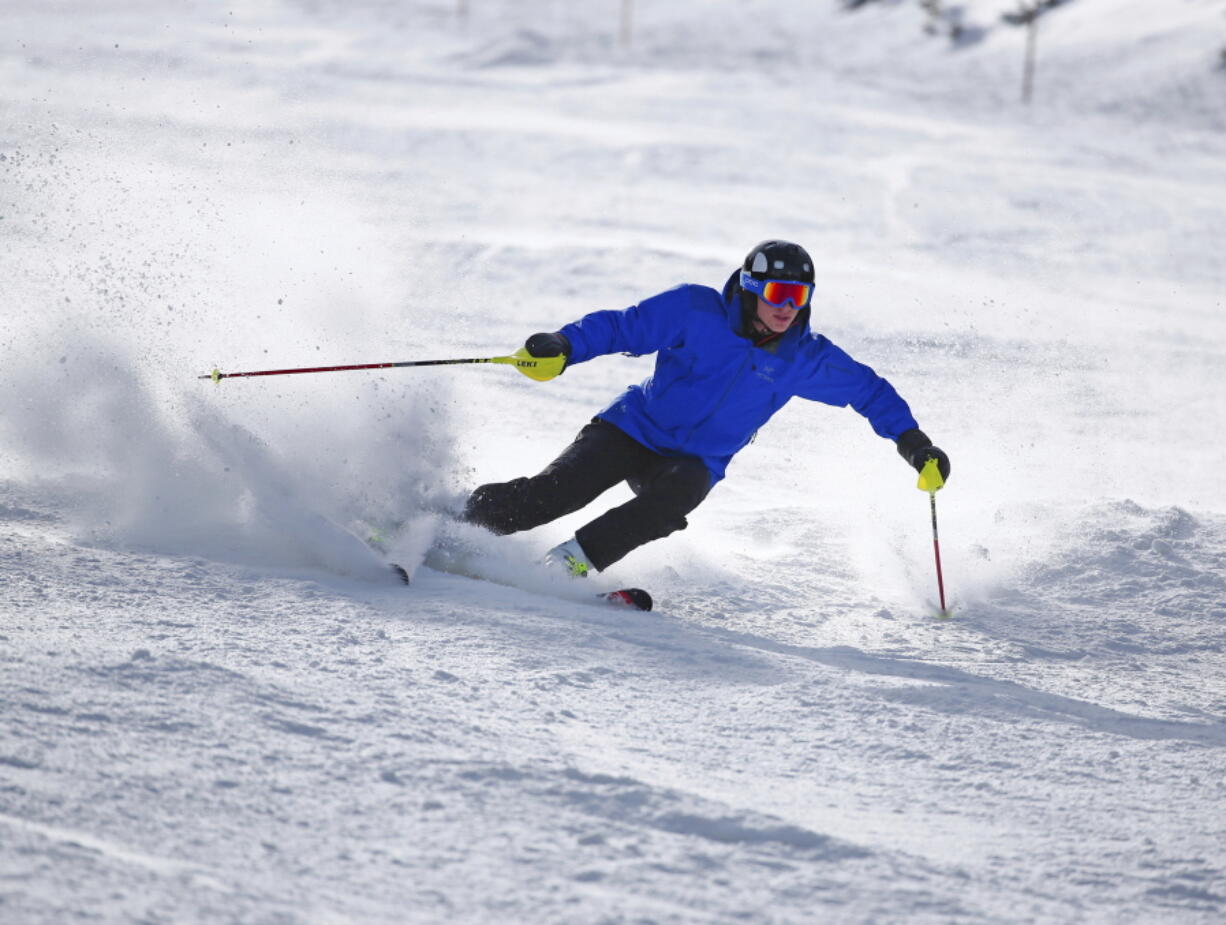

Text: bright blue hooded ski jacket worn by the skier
xmin=562 ymin=274 xmax=918 ymax=485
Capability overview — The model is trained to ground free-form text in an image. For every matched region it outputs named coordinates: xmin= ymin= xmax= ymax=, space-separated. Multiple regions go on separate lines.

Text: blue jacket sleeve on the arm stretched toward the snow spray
xmin=560 ymin=286 xmax=694 ymax=366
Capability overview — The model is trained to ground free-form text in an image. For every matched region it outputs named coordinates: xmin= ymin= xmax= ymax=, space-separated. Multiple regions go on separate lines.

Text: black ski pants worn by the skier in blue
xmin=465 ymin=417 xmax=711 ymax=570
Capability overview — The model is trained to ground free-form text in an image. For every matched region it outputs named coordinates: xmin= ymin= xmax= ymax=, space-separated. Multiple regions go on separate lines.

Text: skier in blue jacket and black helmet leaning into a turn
xmin=465 ymin=240 xmax=949 ymax=577
